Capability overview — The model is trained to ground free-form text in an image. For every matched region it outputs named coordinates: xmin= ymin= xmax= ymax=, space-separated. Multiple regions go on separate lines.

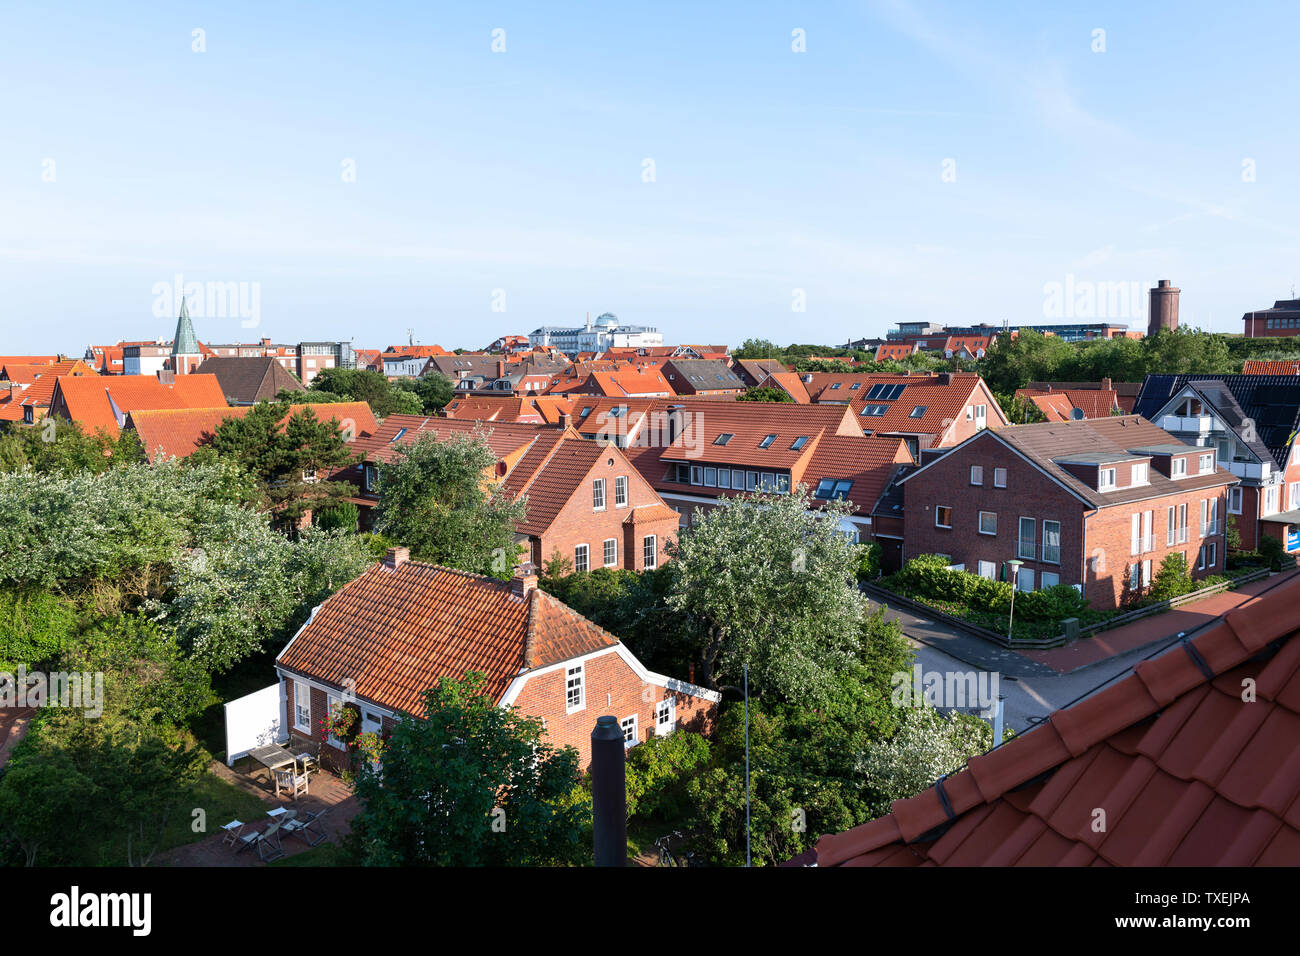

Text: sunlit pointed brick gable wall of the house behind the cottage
xmin=541 ymin=447 xmax=677 ymax=571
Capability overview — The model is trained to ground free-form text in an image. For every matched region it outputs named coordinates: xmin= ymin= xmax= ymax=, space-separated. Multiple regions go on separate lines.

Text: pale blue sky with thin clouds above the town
xmin=0 ymin=0 xmax=1300 ymax=354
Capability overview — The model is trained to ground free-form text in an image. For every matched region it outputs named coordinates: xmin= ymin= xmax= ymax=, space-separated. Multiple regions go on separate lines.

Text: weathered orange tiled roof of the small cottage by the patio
xmin=277 ymin=561 xmax=619 ymax=714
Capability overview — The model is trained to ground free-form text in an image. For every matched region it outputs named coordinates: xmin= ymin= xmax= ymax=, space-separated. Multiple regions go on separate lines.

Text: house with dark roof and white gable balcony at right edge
xmin=1136 ymin=375 xmax=1300 ymax=553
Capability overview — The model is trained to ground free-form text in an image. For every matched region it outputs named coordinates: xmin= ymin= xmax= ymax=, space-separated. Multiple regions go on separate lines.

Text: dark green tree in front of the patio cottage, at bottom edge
xmin=352 ymin=674 xmax=590 ymax=866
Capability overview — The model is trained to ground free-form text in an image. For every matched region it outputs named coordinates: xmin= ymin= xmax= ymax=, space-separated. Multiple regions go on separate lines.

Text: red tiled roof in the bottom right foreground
xmin=816 ymin=578 xmax=1300 ymax=866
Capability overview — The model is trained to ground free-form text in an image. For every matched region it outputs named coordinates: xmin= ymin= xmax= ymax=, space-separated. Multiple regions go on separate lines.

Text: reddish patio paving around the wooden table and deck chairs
xmin=157 ymin=761 xmax=360 ymax=866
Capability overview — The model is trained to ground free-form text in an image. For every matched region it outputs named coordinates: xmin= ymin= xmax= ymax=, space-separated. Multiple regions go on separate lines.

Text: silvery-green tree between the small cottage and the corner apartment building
xmin=667 ymin=485 xmax=867 ymax=701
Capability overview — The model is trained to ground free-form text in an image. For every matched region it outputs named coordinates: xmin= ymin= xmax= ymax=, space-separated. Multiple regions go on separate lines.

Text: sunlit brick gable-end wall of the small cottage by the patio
xmin=514 ymin=652 xmax=718 ymax=770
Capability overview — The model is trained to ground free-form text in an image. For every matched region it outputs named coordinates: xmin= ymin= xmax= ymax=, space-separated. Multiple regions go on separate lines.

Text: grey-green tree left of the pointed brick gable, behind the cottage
xmin=376 ymin=432 xmax=525 ymax=579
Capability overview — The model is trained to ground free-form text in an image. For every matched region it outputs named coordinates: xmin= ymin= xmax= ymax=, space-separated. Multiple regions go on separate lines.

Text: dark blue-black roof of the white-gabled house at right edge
xmin=1134 ymin=375 xmax=1300 ymax=468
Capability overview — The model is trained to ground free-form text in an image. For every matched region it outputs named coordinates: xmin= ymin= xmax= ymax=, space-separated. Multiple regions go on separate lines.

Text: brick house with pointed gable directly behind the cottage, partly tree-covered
xmin=334 ymin=415 xmax=679 ymax=571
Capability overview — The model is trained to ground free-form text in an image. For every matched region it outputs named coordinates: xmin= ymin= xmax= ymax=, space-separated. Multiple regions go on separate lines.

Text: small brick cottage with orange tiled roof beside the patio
xmin=276 ymin=548 xmax=722 ymax=769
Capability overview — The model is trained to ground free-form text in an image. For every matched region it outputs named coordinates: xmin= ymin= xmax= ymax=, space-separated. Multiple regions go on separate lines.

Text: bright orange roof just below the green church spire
xmin=52 ymin=375 xmax=226 ymax=436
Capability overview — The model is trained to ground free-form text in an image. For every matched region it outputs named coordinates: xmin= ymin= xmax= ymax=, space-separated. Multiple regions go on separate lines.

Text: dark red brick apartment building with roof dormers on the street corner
xmin=900 ymin=415 xmax=1238 ymax=609
